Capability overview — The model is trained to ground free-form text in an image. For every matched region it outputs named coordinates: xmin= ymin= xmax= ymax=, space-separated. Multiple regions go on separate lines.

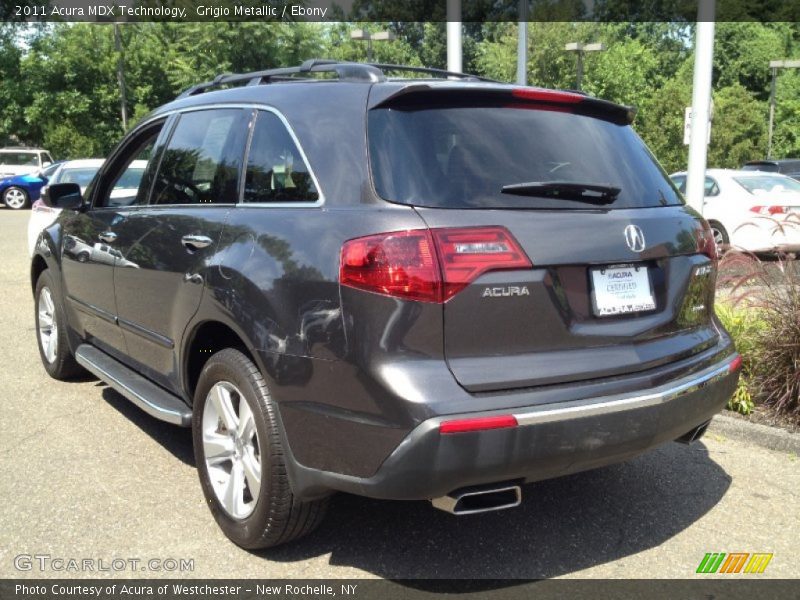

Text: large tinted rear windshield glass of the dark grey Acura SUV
xmin=368 ymin=106 xmax=683 ymax=209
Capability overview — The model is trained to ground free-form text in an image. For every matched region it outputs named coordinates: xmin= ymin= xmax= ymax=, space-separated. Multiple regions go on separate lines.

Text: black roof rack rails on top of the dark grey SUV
xmin=178 ymin=58 xmax=494 ymax=99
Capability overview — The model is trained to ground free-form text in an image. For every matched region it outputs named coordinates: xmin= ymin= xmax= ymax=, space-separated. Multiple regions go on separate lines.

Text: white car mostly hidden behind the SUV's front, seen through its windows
xmin=28 ymin=158 xmax=147 ymax=256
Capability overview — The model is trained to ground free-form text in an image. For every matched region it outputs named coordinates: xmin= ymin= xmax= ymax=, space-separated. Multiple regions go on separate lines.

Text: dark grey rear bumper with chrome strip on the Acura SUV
xmin=290 ymin=354 xmax=739 ymax=500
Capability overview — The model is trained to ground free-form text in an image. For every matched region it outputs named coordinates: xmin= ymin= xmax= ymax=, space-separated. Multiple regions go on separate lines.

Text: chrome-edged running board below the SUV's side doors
xmin=75 ymin=344 xmax=192 ymax=427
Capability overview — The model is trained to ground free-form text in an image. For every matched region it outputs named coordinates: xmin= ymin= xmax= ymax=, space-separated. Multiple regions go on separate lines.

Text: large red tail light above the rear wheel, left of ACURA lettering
xmin=339 ymin=227 xmax=533 ymax=303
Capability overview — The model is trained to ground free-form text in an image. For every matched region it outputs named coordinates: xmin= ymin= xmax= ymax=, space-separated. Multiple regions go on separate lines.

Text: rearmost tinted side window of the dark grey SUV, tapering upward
xmin=244 ymin=111 xmax=319 ymax=202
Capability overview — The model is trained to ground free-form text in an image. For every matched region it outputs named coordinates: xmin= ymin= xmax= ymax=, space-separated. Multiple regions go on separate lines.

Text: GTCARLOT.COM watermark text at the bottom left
xmin=14 ymin=554 xmax=194 ymax=573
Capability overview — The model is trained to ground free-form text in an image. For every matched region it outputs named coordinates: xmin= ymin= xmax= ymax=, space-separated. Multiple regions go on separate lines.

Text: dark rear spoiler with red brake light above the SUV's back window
xmin=371 ymin=84 xmax=636 ymax=125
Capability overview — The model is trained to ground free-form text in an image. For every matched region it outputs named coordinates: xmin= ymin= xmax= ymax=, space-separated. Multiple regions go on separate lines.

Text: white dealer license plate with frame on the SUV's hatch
xmin=589 ymin=263 xmax=656 ymax=318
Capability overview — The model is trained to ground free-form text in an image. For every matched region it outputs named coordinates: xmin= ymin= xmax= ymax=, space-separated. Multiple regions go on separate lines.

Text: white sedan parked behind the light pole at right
xmin=670 ymin=169 xmax=800 ymax=253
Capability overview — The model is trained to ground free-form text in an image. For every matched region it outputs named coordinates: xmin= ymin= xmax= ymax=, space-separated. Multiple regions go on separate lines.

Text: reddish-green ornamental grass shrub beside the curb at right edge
xmin=719 ymin=252 xmax=800 ymax=419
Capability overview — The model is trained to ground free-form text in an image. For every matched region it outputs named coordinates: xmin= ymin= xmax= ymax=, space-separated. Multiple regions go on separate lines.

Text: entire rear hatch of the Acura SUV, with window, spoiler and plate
xmin=368 ymin=84 xmax=718 ymax=392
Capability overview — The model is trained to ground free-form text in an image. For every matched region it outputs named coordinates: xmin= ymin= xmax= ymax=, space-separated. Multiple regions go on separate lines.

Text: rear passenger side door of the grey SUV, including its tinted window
xmin=108 ymin=108 xmax=252 ymax=391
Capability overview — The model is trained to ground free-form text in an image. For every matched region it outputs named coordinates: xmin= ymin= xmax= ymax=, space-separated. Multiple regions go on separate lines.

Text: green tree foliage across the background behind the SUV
xmin=0 ymin=21 xmax=800 ymax=171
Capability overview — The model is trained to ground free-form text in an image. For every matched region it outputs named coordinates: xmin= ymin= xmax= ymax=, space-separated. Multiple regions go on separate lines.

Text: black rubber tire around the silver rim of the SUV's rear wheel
xmin=192 ymin=348 xmax=328 ymax=550
